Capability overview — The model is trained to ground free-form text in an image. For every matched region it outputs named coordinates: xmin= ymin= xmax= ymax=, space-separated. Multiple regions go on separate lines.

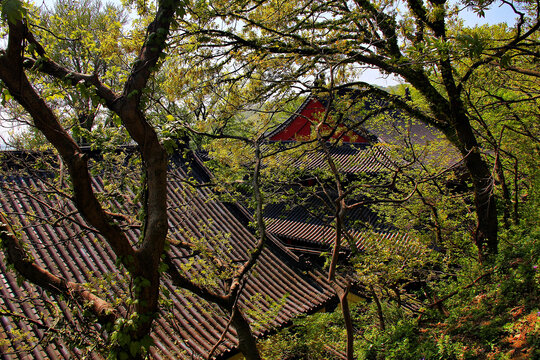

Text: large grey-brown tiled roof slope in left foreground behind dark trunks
xmin=0 ymin=150 xmax=332 ymax=359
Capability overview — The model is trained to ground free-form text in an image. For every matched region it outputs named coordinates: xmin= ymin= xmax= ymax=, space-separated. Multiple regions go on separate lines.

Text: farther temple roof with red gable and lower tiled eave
xmin=264 ymin=89 xmax=442 ymax=258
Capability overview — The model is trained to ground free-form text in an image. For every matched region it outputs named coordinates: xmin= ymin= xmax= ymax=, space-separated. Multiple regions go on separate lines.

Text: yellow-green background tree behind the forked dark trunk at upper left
xmin=2 ymin=0 xmax=136 ymax=149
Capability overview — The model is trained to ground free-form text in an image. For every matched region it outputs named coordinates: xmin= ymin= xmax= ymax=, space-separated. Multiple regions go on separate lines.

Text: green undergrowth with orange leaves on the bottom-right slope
xmin=263 ymin=194 xmax=540 ymax=360
